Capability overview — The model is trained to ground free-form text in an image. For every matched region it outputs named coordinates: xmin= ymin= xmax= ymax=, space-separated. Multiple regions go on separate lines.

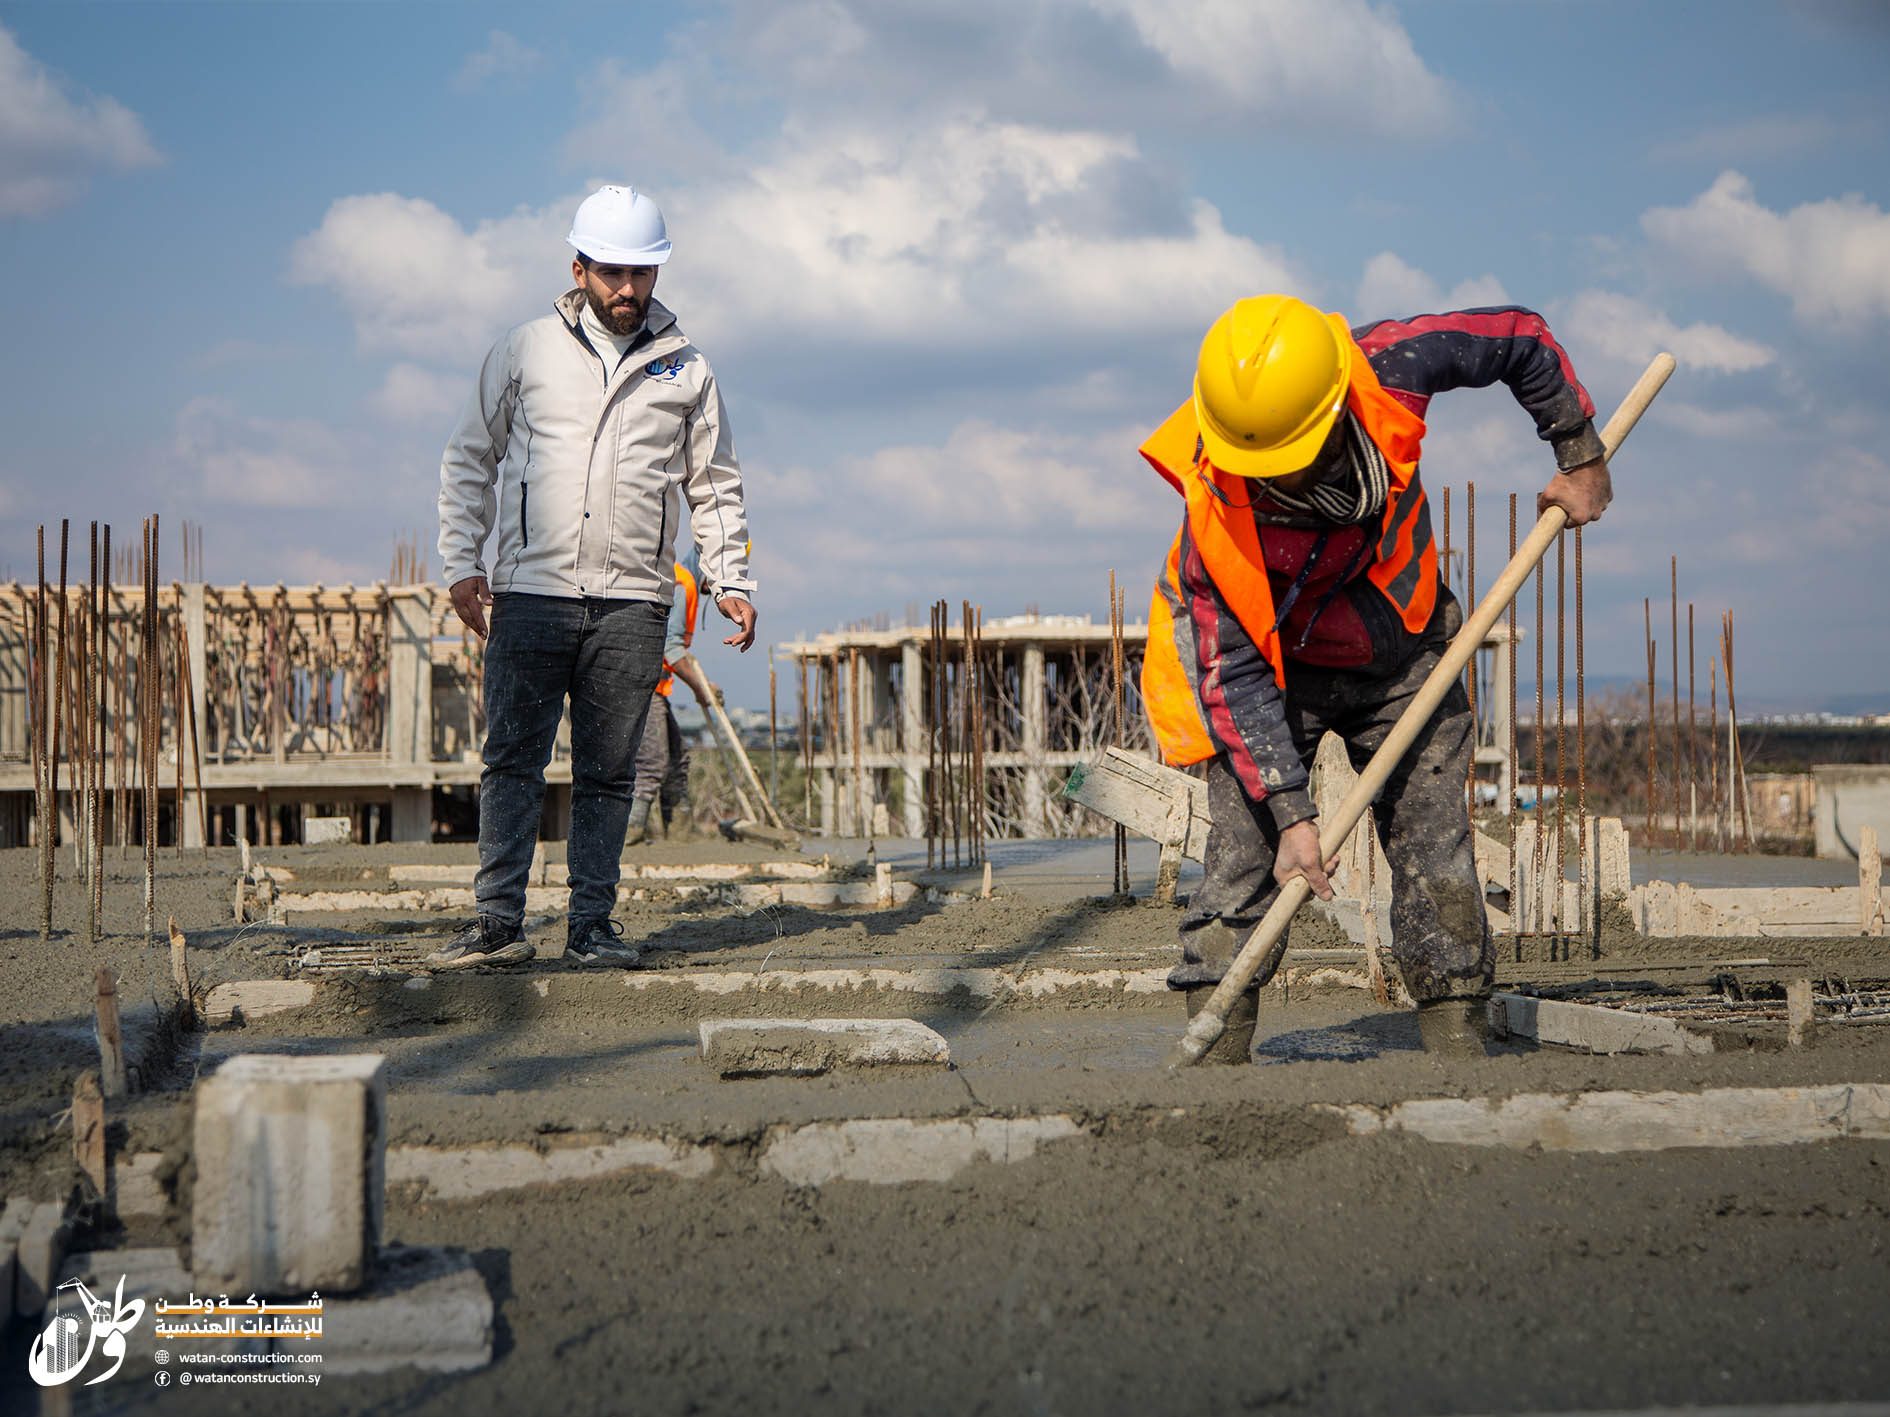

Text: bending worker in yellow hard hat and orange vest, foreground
xmin=1142 ymin=295 xmax=1612 ymax=1062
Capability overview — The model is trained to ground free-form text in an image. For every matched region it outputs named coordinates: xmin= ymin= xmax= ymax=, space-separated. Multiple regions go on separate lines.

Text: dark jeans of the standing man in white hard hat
xmin=473 ymin=593 xmax=669 ymax=926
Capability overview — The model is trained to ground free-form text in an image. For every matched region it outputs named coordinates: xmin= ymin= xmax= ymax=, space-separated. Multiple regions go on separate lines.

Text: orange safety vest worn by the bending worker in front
xmin=1142 ymin=316 xmax=1438 ymax=767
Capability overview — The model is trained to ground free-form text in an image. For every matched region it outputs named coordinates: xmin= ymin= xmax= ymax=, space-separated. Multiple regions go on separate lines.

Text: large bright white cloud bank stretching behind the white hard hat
xmin=289 ymin=121 xmax=1304 ymax=359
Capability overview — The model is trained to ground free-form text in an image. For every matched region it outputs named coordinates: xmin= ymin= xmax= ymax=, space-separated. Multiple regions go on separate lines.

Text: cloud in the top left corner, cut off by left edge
xmin=0 ymin=26 xmax=159 ymax=217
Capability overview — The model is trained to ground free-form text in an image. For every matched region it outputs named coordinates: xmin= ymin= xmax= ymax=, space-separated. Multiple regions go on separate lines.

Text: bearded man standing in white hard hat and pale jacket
xmin=429 ymin=187 xmax=756 ymax=969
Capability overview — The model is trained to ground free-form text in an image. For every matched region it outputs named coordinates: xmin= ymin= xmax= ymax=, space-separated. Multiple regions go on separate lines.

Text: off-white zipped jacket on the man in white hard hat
xmin=440 ymin=291 xmax=754 ymax=605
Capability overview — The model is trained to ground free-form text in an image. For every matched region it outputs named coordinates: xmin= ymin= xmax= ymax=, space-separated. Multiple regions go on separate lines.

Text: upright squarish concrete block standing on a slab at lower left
xmin=191 ymin=1052 xmax=387 ymax=1296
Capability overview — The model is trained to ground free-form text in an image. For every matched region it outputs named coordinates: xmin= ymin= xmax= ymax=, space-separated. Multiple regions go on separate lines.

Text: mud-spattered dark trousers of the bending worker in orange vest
xmin=1168 ymin=605 xmax=1497 ymax=1003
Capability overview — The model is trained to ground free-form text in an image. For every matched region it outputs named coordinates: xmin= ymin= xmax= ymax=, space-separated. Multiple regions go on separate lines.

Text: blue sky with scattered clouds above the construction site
xmin=0 ymin=0 xmax=1890 ymax=709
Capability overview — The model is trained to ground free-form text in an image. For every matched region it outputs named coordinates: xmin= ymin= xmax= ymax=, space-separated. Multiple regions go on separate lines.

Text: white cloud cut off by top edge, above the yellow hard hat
xmin=1096 ymin=0 xmax=1457 ymax=138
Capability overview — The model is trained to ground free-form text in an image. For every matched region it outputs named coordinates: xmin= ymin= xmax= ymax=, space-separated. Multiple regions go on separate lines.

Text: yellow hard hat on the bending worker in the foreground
xmin=1194 ymin=295 xmax=1351 ymax=478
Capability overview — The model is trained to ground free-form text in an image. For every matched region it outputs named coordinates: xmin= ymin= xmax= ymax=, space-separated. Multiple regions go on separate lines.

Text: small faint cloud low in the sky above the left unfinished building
xmin=172 ymin=399 xmax=357 ymax=508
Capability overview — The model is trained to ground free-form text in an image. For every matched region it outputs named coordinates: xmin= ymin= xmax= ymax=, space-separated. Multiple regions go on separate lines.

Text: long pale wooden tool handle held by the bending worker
xmin=1168 ymin=353 xmax=1673 ymax=1067
